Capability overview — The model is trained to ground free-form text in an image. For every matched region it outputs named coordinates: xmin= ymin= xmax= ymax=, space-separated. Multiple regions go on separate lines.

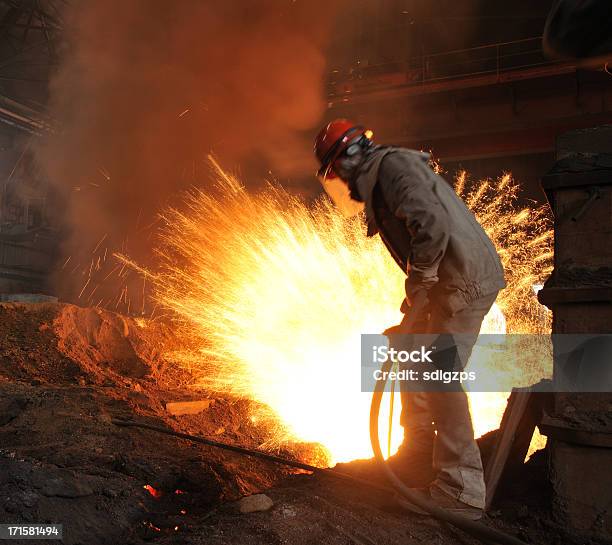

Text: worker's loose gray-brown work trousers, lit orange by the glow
xmin=401 ymin=293 xmax=497 ymax=508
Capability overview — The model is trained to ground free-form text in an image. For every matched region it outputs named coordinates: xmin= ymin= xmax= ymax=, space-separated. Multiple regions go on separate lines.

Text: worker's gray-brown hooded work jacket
xmin=352 ymin=147 xmax=506 ymax=314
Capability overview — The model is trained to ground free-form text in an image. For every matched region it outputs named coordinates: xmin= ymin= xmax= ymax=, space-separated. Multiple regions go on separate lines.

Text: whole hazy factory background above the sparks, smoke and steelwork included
xmin=0 ymin=0 xmax=612 ymax=311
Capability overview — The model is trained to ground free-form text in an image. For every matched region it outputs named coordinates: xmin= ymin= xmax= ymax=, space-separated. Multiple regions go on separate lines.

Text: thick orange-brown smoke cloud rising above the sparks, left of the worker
xmin=37 ymin=0 xmax=337 ymax=304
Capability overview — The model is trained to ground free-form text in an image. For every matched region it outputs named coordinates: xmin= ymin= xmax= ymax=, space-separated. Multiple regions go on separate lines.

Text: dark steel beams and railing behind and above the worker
xmin=327 ymin=0 xmax=612 ymax=202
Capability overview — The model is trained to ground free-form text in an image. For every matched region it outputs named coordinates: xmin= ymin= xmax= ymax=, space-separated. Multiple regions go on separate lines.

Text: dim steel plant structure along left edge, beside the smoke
xmin=0 ymin=0 xmax=65 ymax=293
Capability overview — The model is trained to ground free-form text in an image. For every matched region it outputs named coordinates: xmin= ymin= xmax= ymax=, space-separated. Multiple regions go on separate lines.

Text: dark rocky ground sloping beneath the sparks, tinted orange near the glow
xmin=0 ymin=304 xmax=596 ymax=545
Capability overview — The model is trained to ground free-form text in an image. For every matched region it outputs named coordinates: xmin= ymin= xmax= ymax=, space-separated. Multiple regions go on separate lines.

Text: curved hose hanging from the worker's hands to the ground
xmin=370 ymin=361 xmax=527 ymax=545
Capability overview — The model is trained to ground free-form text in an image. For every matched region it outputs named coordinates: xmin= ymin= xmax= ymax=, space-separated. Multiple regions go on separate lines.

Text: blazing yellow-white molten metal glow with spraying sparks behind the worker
xmin=153 ymin=159 xmax=551 ymax=461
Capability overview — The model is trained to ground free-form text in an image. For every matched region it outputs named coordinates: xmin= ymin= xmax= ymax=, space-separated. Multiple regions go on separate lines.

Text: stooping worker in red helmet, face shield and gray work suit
xmin=314 ymin=119 xmax=505 ymax=520
